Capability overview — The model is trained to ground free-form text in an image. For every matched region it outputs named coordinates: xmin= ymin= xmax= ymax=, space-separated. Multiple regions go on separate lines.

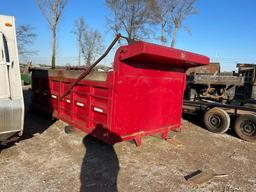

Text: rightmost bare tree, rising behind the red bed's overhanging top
xmin=171 ymin=0 xmax=196 ymax=47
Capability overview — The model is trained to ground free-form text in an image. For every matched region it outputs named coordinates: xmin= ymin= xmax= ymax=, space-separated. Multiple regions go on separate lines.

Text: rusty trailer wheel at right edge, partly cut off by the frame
xmin=235 ymin=114 xmax=256 ymax=141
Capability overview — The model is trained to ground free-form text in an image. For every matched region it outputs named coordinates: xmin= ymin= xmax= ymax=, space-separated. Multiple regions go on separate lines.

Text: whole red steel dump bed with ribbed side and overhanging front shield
xmin=32 ymin=42 xmax=209 ymax=144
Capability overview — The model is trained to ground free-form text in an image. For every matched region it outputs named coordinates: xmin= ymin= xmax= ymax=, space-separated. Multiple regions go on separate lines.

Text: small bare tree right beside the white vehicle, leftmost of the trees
xmin=16 ymin=25 xmax=36 ymax=56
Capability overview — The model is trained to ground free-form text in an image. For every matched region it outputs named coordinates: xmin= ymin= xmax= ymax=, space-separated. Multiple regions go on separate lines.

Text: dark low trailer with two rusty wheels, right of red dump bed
xmin=183 ymin=100 xmax=256 ymax=141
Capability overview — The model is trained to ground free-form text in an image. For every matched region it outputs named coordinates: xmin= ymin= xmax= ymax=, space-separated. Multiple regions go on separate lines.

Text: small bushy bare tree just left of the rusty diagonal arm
xmin=81 ymin=27 xmax=104 ymax=67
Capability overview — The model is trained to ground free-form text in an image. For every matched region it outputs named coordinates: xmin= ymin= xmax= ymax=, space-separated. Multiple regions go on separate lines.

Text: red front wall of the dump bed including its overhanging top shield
xmin=110 ymin=42 xmax=209 ymax=138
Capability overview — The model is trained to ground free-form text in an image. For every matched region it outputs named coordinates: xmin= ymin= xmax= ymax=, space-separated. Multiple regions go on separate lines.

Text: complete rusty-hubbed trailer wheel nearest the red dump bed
xmin=204 ymin=107 xmax=230 ymax=133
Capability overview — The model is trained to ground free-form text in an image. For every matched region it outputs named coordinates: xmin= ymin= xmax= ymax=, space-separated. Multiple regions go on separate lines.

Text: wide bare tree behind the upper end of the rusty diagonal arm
xmin=106 ymin=0 xmax=158 ymax=44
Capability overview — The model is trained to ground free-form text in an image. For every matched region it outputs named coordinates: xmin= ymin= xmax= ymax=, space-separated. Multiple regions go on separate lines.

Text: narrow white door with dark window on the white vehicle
xmin=0 ymin=32 xmax=10 ymax=99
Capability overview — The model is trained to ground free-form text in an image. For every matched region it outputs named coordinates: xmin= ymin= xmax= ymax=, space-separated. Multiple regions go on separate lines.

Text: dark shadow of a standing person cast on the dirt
xmin=80 ymin=127 xmax=120 ymax=192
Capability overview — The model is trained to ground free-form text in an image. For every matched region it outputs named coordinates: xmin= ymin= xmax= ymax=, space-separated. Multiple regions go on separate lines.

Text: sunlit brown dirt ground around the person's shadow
xmin=0 ymin=90 xmax=256 ymax=192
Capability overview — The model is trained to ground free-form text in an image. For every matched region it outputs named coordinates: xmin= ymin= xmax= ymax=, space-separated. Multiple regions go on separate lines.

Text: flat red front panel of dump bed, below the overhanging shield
xmin=114 ymin=57 xmax=186 ymax=136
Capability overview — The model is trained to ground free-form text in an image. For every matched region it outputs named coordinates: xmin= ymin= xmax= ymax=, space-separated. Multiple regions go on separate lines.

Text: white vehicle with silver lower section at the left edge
xmin=0 ymin=15 xmax=24 ymax=143
